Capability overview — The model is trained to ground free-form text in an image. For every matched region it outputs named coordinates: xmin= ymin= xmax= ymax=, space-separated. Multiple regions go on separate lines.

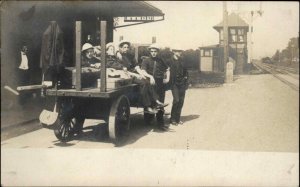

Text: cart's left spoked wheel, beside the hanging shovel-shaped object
xmin=54 ymin=99 xmax=84 ymax=142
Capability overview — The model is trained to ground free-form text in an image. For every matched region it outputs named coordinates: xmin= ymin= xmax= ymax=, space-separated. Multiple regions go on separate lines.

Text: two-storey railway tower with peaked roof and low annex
xmin=199 ymin=13 xmax=249 ymax=74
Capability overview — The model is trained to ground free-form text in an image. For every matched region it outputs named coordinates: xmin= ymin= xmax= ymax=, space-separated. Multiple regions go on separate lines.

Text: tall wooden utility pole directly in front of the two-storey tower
xmin=223 ymin=1 xmax=228 ymax=80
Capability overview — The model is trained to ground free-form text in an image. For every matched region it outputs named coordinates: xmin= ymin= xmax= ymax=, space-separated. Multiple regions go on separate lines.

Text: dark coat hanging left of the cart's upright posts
xmin=40 ymin=21 xmax=64 ymax=82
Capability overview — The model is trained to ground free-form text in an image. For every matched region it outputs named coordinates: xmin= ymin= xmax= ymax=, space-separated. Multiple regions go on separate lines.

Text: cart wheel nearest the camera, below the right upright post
xmin=108 ymin=95 xmax=130 ymax=142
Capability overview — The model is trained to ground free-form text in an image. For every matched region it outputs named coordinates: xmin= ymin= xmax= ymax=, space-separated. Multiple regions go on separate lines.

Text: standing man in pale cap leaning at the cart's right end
xmin=141 ymin=44 xmax=169 ymax=130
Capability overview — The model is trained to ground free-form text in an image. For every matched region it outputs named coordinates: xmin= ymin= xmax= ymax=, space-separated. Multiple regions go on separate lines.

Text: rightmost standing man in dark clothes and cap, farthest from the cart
xmin=169 ymin=47 xmax=188 ymax=125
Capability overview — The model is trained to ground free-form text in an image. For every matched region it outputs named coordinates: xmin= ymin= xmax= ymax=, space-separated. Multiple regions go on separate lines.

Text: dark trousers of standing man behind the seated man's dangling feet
xmin=155 ymin=78 xmax=166 ymax=126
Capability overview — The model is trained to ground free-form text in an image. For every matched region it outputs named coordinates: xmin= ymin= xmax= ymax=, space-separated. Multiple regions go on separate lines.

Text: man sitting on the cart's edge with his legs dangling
xmin=119 ymin=40 xmax=163 ymax=114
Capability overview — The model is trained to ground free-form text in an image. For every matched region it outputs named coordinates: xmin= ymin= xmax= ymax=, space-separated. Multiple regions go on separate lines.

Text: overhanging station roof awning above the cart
xmin=1 ymin=1 xmax=164 ymax=20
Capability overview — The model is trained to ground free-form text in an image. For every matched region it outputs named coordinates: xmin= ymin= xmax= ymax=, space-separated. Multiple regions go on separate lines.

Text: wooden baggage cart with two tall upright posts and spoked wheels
xmin=46 ymin=21 xmax=154 ymax=142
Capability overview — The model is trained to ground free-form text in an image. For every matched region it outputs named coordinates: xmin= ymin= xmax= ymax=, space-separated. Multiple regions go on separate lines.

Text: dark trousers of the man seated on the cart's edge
xmin=133 ymin=78 xmax=157 ymax=107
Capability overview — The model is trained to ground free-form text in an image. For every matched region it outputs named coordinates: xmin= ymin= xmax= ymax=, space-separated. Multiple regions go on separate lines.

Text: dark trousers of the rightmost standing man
xmin=171 ymin=84 xmax=185 ymax=123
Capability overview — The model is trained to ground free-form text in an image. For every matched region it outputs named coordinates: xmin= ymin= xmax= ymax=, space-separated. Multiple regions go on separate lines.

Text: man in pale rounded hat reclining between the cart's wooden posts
xmin=81 ymin=43 xmax=100 ymax=68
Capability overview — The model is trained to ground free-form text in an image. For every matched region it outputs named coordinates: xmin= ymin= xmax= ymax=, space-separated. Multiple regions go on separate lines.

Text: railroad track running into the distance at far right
xmin=253 ymin=62 xmax=299 ymax=91
